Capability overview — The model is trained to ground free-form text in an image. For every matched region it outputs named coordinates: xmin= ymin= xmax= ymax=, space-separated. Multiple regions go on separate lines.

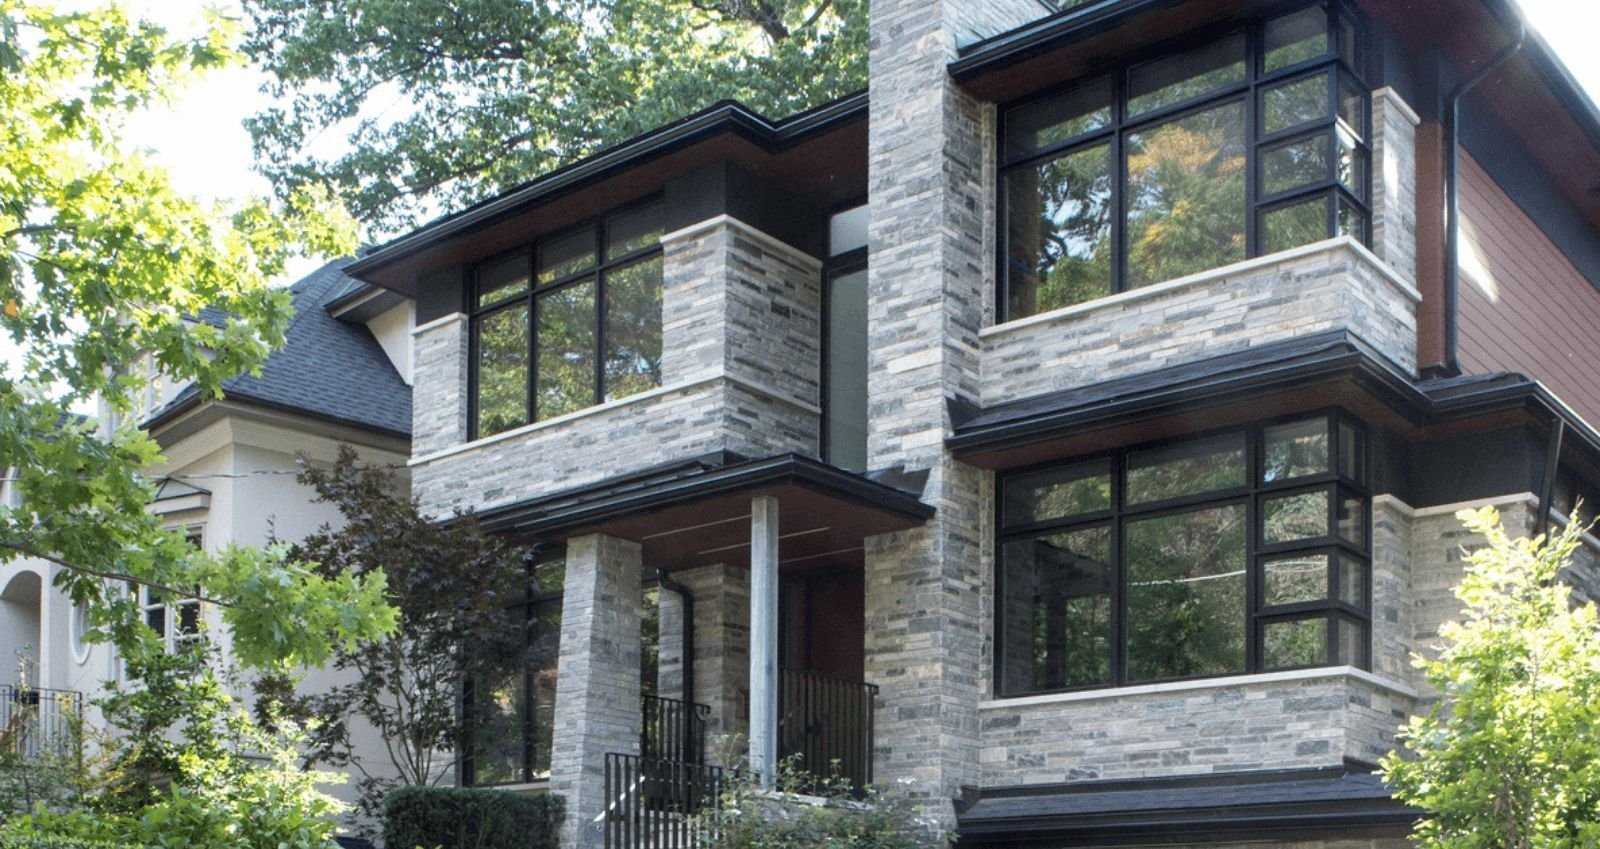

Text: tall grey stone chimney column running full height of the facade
xmin=866 ymin=0 xmax=1046 ymax=822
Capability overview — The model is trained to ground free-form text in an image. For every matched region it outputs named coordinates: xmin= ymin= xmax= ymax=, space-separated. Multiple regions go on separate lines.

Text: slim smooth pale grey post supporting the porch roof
xmin=750 ymin=496 xmax=778 ymax=787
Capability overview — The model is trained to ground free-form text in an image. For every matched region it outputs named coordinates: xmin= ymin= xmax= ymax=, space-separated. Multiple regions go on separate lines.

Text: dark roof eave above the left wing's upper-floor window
xmin=346 ymin=91 xmax=867 ymax=296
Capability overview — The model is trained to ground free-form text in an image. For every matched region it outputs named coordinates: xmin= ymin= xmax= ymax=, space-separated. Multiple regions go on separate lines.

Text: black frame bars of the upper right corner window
xmin=994 ymin=0 xmax=1374 ymax=325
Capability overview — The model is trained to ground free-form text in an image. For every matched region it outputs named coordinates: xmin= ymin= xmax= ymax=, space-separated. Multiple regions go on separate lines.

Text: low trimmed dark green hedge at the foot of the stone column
xmin=384 ymin=787 xmax=566 ymax=849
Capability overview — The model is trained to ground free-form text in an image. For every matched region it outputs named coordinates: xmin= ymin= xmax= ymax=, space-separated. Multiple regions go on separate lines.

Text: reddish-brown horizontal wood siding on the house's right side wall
xmin=1459 ymin=153 xmax=1600 ymax=424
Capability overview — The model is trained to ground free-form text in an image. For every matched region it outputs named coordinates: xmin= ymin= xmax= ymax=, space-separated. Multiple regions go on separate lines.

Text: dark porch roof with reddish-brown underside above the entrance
xmin=478 ymin=454 xmax=934 ymax=572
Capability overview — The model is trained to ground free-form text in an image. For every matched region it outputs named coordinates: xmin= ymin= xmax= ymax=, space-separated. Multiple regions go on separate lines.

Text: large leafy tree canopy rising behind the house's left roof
xmin=245 ymin=0 xmax=867 ymax=230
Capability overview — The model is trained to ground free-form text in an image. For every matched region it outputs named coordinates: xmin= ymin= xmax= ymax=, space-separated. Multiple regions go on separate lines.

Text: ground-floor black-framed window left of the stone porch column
xmin=461 ymin=548 xmax=566 ymax=787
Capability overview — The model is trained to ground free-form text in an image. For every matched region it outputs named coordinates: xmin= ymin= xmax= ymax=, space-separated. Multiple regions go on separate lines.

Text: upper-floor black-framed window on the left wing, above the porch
xmin=470 ymin=201 xmax=661 ymax=438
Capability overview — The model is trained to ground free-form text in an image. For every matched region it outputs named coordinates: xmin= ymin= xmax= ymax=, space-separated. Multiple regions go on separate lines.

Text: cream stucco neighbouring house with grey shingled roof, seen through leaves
xmin=0 ymin=259 xmax=413 ymax=818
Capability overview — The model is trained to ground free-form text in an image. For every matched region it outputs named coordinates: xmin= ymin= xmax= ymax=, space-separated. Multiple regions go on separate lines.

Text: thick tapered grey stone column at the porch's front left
xmin=550 ymin=534 xmax=642 ymax=847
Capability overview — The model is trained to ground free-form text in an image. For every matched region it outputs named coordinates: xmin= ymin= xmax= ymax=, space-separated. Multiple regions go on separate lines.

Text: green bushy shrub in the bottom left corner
xmin=0 ymin=641 xmax=346 ymax=849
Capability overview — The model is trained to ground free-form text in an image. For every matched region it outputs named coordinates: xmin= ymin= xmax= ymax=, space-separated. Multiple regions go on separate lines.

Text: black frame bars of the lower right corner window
xmin=990 ymin=408 xmax=1374 ymax=699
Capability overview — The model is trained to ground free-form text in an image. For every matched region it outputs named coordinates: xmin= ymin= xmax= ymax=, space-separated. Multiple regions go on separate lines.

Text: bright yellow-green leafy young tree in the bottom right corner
xmin=1382 ymin=507 xmax=1600 ymax=849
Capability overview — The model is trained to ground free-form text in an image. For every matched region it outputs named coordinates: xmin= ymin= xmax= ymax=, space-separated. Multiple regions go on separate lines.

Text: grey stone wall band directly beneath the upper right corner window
xmin=982 ymin=238 xmax=1421 ymax=405
